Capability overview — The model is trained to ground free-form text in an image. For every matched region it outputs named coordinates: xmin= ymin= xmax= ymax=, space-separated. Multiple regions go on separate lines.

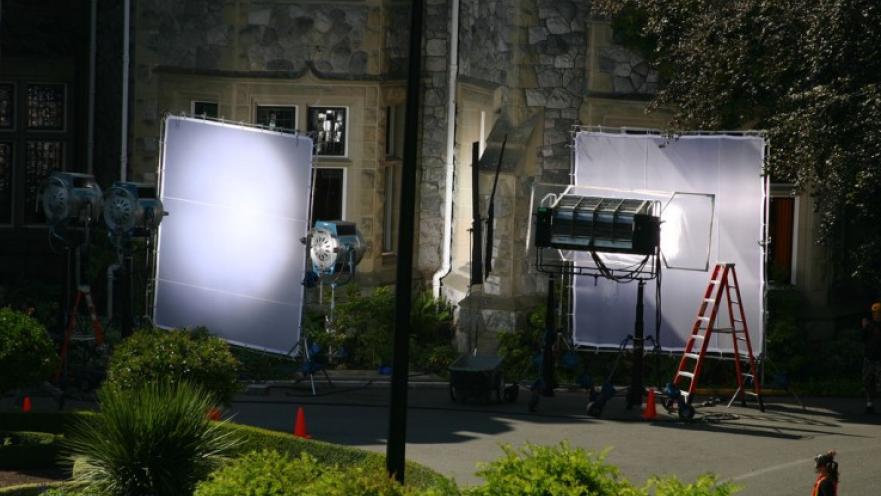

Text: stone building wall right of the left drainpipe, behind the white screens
xmin=130 ymin=0 xmax=832 ymax=349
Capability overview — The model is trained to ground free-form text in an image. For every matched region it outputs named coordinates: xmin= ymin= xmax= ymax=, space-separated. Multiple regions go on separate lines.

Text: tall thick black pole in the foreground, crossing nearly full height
xmin=385 ymin=0 xmax=423 ymax=483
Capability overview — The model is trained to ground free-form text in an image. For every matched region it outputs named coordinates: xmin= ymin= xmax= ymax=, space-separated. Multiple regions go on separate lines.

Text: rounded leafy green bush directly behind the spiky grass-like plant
xmin=107 ymin=328 xmax=239 ymax=404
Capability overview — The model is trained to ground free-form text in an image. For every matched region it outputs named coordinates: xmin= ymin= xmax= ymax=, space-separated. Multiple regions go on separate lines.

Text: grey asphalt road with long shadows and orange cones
xmin=230 ymin=384 xmax=881 ymax=496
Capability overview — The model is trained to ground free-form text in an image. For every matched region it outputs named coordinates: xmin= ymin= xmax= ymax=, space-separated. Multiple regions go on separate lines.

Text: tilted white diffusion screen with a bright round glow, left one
xmin=154 ymin=117 xmax=312 ymax=353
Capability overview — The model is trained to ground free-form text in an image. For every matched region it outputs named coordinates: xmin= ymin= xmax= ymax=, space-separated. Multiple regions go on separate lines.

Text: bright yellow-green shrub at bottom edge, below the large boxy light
xmin=465 ymin=442 xmax=642 ymax=496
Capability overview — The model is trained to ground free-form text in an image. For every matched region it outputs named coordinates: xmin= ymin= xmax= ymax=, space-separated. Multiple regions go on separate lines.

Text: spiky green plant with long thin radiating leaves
xmin=65 ymin=381 xmax=235 ymax=496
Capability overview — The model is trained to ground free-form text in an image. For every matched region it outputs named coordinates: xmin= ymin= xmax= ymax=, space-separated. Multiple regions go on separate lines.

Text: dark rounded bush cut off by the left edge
xmin=0 ymin=308 xmax=58 ymax=394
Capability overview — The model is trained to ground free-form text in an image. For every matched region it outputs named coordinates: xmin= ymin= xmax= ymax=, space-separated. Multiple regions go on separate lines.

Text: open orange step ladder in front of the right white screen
xmin=673 ymin=263 xmax=765 ymax=411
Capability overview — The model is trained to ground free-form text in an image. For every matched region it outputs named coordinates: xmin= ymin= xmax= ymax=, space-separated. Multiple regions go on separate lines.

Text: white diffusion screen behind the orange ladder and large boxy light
xmin=573 ymin=132 xmax=766 ymax=354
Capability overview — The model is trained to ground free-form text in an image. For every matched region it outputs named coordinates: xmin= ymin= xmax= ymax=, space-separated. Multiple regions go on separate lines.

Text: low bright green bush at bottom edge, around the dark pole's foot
xmin=194 ymin=450 xmax=451 ymax=496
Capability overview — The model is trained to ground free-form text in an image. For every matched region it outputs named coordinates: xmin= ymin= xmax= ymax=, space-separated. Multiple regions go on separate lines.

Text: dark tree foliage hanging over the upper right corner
xmin=594 ymin=0 xmax=881 ymax=284
